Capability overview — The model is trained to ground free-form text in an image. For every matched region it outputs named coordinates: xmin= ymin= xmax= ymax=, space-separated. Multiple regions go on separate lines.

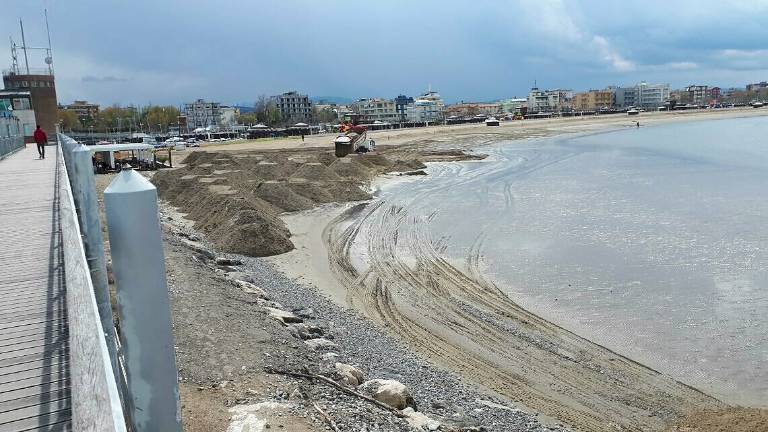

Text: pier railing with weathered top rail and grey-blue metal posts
xmin=59 ymin=134 xmax=181 ymax=432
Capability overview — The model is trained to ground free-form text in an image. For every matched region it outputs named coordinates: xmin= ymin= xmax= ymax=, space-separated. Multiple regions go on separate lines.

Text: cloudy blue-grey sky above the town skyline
xmin=0 ymin=0 xmax=768 ymax=105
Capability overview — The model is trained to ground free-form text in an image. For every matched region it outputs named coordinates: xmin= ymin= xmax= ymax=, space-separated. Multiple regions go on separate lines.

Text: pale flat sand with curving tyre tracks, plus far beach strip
xmin=271 ymin=110 xmax=768 ymax=431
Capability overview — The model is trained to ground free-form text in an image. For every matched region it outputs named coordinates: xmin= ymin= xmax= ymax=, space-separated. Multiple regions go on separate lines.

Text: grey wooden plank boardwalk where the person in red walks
xmin=0 ymin=145 xmax=71 ymax=432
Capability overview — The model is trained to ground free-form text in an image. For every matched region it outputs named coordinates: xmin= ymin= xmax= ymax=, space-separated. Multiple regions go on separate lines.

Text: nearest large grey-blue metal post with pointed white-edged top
xmin=104 ymin=170 xmax=181 ymax=432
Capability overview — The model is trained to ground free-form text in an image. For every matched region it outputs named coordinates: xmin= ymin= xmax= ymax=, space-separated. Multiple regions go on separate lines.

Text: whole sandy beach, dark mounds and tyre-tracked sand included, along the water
xmin=157 ymin=109 xmax=768 ymax=431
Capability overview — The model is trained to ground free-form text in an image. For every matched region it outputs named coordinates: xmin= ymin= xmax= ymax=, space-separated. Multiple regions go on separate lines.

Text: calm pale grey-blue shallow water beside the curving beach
xmin=381 ymin=118 xmax=768 ymax=406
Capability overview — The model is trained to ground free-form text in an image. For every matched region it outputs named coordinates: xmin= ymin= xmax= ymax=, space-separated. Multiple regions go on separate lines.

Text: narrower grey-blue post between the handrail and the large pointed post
xmin=70 ymin=144 xmax=122 ymax=385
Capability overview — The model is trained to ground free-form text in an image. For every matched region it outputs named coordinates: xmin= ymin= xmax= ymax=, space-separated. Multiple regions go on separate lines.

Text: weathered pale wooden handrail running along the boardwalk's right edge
xmin=56 ymin=144 xmax=126 ymax=432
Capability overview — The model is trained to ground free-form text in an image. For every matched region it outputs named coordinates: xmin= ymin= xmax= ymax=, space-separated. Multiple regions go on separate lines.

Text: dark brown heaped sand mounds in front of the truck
xmin=152 ymin=150 xmax=420 ymax=256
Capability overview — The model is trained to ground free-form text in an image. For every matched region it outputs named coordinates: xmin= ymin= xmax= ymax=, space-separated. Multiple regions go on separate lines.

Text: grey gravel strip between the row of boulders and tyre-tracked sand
xmin=234 ymin=255 xmax=566 ymax=432
